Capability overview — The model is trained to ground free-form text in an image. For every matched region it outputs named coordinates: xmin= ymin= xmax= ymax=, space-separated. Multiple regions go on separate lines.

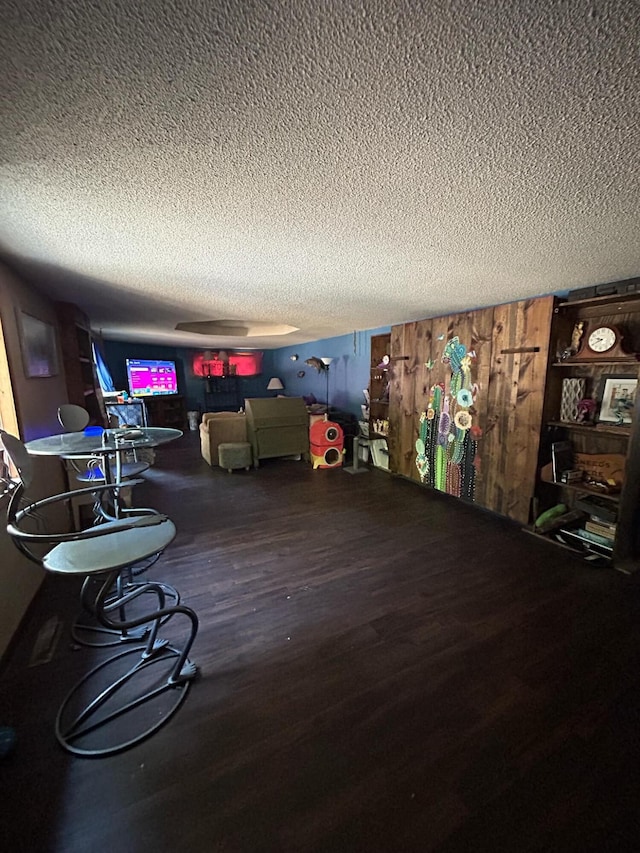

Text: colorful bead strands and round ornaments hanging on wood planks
xmin=416 ymin=336 xmax=482 ymax=500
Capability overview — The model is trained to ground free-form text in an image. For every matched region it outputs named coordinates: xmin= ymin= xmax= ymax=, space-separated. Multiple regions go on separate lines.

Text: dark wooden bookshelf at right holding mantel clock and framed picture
xmin=537 ymin=288 xmax=640 ymax=572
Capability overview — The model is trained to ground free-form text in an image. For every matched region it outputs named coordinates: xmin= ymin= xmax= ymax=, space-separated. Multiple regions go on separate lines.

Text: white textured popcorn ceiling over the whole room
xmin=0 ymin=0 xmax=640 ymax=348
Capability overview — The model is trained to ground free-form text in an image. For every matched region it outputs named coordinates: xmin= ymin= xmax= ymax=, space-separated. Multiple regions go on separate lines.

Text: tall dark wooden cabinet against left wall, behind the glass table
xmin=55 ymin=302 xmax=106 ymax=426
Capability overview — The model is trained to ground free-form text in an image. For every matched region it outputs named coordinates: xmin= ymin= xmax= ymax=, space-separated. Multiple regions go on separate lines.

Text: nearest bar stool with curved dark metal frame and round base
xmin=0 ymin=430 xmax=198 ymax=756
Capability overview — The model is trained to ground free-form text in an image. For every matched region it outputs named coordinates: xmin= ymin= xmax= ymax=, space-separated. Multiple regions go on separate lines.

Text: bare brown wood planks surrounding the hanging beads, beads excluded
xmin=389 ymin=296 xmax=554 ymax=523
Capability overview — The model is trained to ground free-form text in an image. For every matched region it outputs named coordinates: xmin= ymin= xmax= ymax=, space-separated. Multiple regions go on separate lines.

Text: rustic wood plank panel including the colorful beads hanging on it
xmin=389 ymin=296 xmax=554 ymax=523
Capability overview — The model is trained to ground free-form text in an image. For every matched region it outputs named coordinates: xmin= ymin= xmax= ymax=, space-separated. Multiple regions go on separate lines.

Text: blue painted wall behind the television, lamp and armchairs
xmin=102 ymin=326 xmax=391 ymax=418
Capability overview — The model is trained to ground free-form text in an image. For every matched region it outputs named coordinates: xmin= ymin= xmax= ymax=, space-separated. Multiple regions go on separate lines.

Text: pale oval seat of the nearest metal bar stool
xmin=42 ymin=516 xmax=176 ymax=575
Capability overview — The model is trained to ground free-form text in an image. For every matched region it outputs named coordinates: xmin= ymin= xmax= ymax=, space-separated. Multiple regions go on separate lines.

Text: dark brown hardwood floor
xmin=0 ymin=434 xmax=640 ymax=853
